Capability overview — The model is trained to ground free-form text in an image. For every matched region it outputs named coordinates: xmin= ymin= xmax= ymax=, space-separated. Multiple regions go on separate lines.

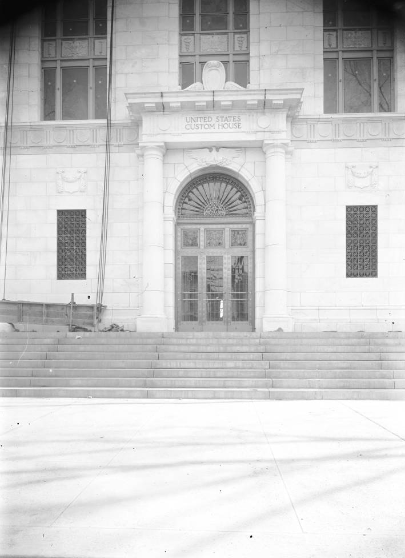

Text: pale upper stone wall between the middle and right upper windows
xmin=250 ymin=0 xmax=323 ymax=115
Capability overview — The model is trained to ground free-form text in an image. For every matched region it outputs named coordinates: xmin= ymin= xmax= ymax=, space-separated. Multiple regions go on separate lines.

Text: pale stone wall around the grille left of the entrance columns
xmin=0 ymin=128 xmax=140 ymax=326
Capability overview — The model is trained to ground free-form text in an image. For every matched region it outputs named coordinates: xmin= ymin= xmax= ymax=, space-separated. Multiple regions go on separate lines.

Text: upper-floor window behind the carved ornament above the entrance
xmin=180 ymin=0 xmax=249 ymax=89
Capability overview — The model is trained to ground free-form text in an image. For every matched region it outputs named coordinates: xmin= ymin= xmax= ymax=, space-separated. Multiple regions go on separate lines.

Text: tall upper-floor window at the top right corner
xmin=323 ymin=0 xmax=394 ymax=113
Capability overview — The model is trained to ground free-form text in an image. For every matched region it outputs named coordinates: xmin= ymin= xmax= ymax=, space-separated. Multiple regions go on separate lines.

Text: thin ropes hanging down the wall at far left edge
xmin=0 ymin=22 xmax=15 ymax=300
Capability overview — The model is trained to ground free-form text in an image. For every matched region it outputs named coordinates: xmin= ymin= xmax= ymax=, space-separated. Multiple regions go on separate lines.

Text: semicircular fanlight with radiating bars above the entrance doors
xmin=177 ymin=173 xmax=252 ymax=219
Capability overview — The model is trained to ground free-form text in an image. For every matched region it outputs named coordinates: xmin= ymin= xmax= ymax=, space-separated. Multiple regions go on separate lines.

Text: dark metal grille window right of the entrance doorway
xmin=346 ymin=205 xmax=378 ymax=277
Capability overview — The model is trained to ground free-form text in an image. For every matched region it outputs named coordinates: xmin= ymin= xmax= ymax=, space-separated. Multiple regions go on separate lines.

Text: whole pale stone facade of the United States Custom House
xmin=0 ymin=0 xmax=405 ymax=331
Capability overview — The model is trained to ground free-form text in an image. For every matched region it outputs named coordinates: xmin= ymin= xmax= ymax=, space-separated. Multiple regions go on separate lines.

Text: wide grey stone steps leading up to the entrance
xmin=0 ymin=332 xmax=405 ymax=399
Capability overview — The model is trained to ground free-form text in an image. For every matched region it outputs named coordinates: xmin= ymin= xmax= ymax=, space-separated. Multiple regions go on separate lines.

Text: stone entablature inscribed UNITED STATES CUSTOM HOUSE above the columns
xmin=126 ymin=89 xmax=303 ymax=148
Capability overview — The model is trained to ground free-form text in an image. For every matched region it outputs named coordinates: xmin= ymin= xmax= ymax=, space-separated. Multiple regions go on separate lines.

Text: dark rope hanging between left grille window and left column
xmin=96 ymin=0 xmax=115 ymax=324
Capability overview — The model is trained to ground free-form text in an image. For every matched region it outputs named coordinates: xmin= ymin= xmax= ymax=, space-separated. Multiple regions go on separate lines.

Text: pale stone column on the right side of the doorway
xmin=263 ymin=142 xmax=292 ymax=331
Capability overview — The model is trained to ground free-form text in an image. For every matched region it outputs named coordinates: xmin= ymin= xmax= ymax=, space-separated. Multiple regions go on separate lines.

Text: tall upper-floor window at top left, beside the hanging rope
xmin=42 ymin=0 xmax=107 ymax=120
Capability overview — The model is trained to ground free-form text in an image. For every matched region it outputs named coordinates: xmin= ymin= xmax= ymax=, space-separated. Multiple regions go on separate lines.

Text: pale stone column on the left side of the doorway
xmin=137 ymin=143 xmax=167 ymax=332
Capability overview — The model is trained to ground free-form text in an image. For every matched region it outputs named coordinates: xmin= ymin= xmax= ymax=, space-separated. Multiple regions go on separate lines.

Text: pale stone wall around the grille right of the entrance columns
xmin=287 ymin=138 xmax=405 ymax=331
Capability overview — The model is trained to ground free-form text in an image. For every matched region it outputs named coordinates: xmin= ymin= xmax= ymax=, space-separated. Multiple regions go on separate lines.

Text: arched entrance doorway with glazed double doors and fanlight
xmin=176 ymin=173 xmax=254 ymax=331
